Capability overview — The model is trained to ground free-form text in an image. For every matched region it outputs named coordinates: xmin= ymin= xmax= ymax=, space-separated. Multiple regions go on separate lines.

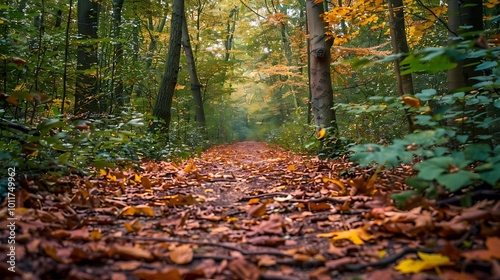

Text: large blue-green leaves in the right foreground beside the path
xmin=344 ymin=38 xmax=500 ymax=206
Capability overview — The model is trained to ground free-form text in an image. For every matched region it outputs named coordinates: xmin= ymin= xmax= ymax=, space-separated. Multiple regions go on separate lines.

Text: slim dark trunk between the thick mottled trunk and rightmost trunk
xmin=387 ymin=0 xmax=415 ymax=132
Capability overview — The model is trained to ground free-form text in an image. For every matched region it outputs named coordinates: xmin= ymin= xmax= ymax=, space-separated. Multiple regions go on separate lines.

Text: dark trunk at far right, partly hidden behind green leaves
xmin=447 ymin=0 xmax=483 ymax=92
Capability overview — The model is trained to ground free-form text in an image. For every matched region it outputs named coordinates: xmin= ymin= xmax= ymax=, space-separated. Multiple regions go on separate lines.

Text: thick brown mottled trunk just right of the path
xmin=306 ymin=0 xmax=338 ymax=129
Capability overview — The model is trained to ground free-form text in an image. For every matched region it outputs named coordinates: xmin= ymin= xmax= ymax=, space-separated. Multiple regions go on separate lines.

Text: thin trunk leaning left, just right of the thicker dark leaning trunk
xmin=182 ymin=10 xmax=205 ymax=127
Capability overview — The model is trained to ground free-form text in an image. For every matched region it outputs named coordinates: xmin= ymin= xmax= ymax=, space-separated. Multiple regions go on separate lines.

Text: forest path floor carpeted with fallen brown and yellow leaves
xmin=0 ymin=142 xmax=500 ymax=280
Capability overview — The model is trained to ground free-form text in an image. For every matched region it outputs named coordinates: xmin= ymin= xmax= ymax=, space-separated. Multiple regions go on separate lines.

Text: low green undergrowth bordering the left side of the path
xmin=0 ymin=110 xmax=199 ymax=177
